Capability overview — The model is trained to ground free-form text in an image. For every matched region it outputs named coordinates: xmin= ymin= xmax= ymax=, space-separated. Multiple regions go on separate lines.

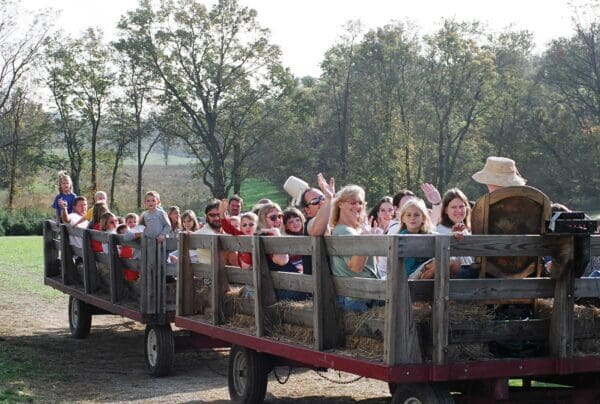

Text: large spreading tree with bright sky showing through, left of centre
xmin=119 ymin=0 xmax=285 ymax=197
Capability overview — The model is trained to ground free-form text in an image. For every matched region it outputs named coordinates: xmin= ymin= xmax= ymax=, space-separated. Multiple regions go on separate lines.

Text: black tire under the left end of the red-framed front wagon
xmin=227 ymin=345 xmax=269 ymax=404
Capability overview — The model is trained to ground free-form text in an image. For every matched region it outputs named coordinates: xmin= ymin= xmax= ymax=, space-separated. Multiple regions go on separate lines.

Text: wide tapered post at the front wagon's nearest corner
xmin=383 ymin=236 xmax=423 ymax=366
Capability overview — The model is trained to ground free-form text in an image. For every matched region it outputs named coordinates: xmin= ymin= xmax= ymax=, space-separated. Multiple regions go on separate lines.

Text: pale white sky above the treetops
xmin=21 ymin=0 xmax=573 ymax=77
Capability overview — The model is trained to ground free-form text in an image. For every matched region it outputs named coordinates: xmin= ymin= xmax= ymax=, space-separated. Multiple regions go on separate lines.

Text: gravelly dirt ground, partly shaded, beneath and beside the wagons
xmin=0 ymin=279 xmax=390 ymax=404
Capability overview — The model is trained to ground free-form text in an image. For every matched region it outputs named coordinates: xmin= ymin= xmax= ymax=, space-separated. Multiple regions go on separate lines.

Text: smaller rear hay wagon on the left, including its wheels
xmin=44 ymin=221 xmax=185 ymax=376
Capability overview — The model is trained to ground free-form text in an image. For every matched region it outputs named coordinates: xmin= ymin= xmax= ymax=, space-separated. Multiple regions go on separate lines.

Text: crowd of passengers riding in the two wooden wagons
xmin=52 ymin=157 xmax=600 ymax=311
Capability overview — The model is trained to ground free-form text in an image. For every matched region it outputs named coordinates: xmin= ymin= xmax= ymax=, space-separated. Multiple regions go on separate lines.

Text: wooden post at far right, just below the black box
xmin=549 ymin=236 xmax=578 ymax=358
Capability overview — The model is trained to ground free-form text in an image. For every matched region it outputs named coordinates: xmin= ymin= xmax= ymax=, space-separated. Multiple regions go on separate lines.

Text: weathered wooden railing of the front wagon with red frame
xmin=177 ymin=230 xmax=600 ymax=370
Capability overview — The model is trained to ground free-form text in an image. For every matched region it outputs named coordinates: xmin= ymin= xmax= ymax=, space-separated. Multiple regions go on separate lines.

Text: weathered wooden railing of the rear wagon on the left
xmin=44 ymin=221 xmax=177 ymax=322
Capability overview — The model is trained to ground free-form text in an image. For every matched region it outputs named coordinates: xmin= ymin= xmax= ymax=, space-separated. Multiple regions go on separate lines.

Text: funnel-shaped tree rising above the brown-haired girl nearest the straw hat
xmin=423 ymin=20 xmax=495 ymax=189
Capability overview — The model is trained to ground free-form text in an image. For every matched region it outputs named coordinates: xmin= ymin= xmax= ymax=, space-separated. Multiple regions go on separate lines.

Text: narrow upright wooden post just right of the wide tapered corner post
xmin=431 ymin=235 xmax=452 ymax=365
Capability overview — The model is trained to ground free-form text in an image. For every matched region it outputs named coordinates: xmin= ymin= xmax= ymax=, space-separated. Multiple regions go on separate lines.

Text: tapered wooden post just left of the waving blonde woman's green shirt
xmin=311 ymin=237 xmax=346 ymax=351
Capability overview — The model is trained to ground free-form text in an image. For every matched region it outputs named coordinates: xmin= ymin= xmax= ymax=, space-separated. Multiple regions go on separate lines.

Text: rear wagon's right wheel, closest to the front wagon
xmin=144 ymin=324 xmax=175 ymax=377
